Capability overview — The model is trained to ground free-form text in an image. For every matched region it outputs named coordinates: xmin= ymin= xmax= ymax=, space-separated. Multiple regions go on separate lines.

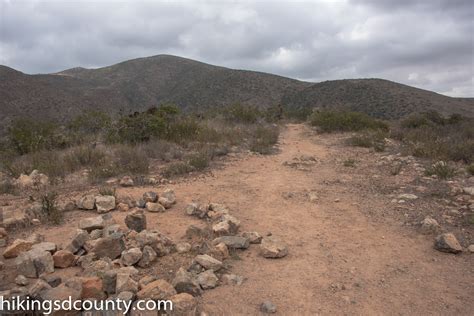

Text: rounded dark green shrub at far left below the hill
xmin=7 ymin=118 xmax=66 ymax=155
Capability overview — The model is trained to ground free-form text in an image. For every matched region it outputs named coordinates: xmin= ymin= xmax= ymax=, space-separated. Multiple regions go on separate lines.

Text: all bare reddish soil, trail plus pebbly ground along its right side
xmin=0 ymin=124 xmax=474 ymax=315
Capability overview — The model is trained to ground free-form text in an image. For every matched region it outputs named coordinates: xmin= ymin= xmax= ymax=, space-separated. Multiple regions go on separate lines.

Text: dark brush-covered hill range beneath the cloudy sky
xmin=0 ymin=55 xmax=474 ymax=126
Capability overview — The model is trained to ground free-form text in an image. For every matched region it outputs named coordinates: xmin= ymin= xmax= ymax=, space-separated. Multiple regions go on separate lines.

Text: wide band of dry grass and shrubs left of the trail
xmin=0 ymin=104 xmax=278 ymax=182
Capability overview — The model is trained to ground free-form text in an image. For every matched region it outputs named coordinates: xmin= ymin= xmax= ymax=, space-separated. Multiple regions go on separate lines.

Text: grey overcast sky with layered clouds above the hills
xmin=0 ymin=0 xmax=474 ymax=97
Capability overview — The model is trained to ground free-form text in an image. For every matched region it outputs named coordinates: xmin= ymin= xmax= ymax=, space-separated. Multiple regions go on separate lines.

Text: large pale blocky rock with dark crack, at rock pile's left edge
xmin=15 ymin=249 xmax=54 ymax=278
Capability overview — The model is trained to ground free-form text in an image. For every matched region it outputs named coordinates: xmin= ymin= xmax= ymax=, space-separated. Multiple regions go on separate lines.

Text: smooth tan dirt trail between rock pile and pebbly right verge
xmin=5 ymin=125 xmax=474 ymax=315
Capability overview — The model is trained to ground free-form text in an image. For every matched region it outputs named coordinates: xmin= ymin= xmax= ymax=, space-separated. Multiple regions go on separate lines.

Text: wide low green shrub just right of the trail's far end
xmin=310 ymin=110 xmax=388 ymax=133
